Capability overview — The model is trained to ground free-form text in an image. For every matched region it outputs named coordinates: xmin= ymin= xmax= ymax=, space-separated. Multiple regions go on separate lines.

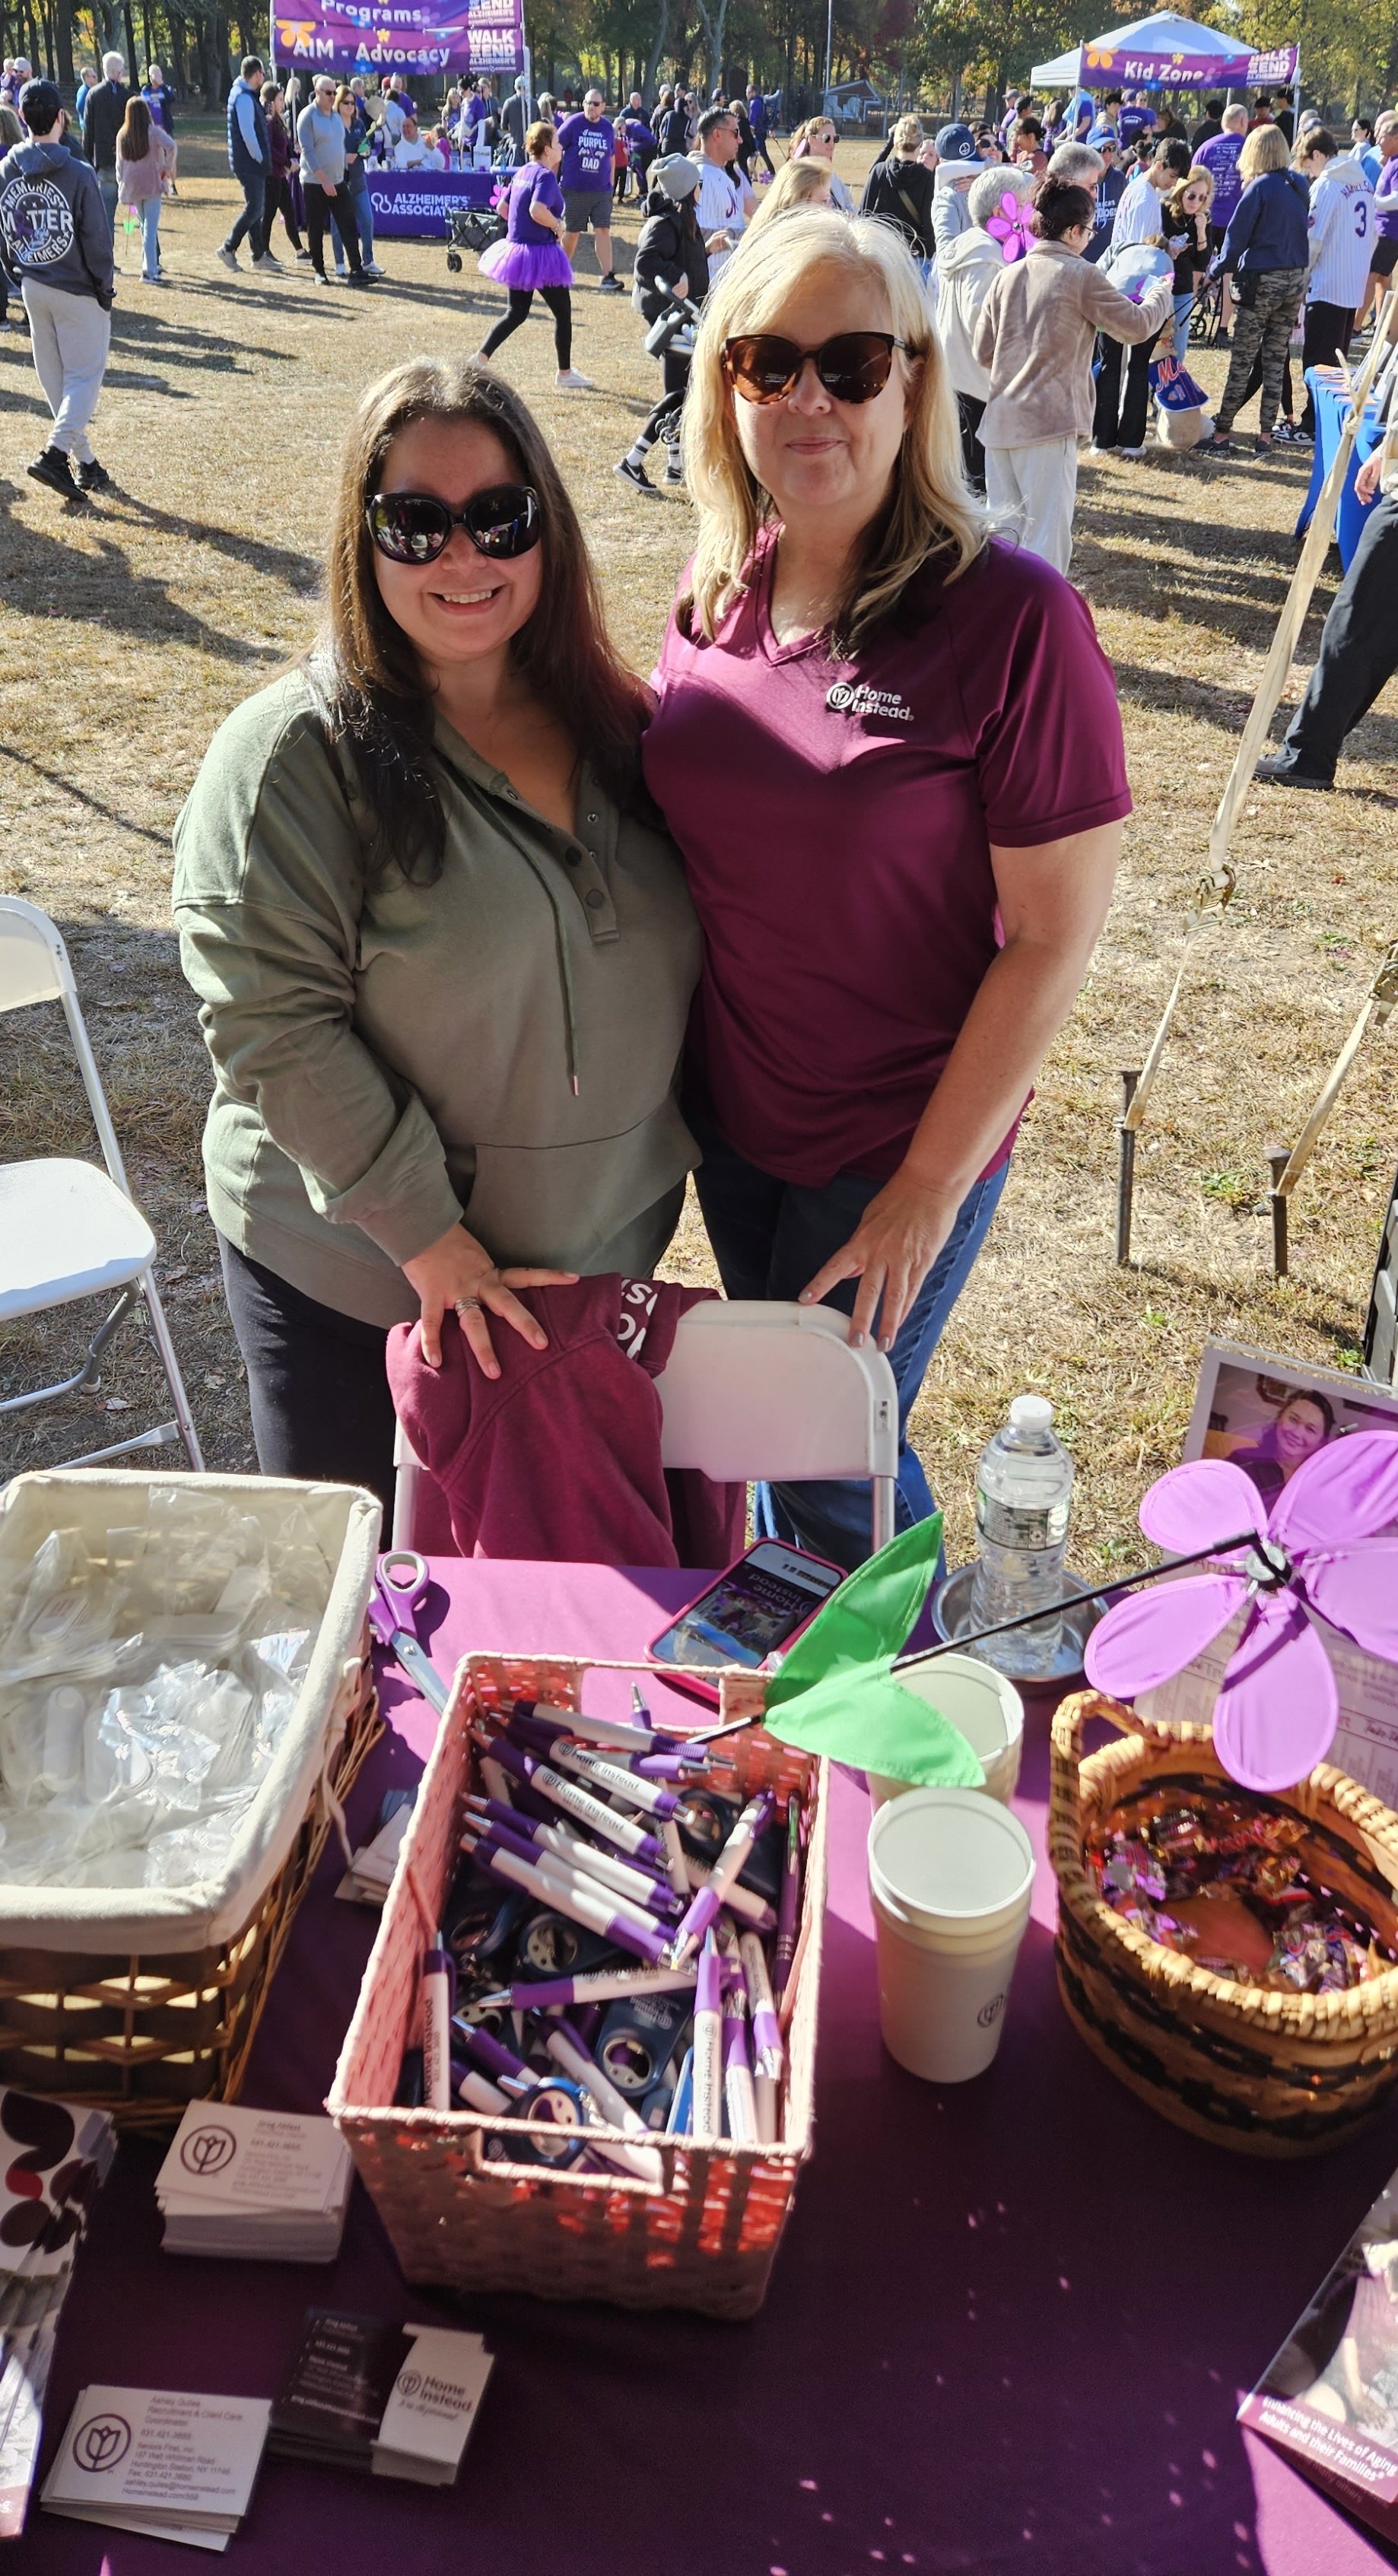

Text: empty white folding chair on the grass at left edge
xmin=0 ymin=894 xmax=203 ymax=1471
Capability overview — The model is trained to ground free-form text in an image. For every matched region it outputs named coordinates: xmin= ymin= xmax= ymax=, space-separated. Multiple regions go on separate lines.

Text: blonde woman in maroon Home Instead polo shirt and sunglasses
xmin=643 ymin=211 xmax=1130 ymax=1566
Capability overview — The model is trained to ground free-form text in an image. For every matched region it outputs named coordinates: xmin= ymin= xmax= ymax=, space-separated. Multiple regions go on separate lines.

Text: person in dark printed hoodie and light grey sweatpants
xmin=0 ymin=80 xmax=116 ymax=502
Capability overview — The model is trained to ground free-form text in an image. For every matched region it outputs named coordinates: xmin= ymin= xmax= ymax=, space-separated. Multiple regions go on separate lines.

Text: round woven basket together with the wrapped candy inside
xmin=1048 ymin=1690 xmax=1398 ymax=2156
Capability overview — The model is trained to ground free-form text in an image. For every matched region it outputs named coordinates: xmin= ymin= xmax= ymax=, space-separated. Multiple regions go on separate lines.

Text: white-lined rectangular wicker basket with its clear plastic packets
xmin=0 ymin=1469 xmax=379 ymax=2128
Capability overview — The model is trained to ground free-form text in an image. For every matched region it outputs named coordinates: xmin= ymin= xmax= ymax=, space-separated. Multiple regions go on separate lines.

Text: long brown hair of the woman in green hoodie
xmin=314 ymin=358 xmax=649 ymax=884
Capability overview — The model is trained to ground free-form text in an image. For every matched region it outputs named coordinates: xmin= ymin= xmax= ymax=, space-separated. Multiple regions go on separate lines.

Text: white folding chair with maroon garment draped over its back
xmin=394 ymin=1298 xmax=898 ymax=1548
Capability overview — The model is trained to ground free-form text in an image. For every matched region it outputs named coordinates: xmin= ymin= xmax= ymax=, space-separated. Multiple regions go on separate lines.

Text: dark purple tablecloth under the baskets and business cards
xmin=15 ymin=1561 xmax=1398 ymax=2576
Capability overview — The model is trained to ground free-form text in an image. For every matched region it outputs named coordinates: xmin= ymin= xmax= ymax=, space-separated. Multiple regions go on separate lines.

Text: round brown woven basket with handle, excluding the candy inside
xmin=1048 ymin=1690 xmax=1398 ymax=2156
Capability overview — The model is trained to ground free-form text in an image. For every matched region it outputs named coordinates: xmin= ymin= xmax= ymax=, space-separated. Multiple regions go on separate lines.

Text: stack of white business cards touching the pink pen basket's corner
xmin=154 ymin=2102 xmax=355 ymax=2262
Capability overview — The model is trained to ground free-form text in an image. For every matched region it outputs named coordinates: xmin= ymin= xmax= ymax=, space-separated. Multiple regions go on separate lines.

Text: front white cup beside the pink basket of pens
xmin=868 ymin=1788 xmax=1035 ymax=2084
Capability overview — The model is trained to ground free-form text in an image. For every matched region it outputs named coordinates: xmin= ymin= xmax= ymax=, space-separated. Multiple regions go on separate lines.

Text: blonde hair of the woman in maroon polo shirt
xmin=682 ymin=206 xmax=986 ymax=652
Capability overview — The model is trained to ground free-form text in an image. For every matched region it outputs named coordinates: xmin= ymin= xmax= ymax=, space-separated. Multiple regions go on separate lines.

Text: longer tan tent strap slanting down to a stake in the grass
xmin=1117 ymin=297 xmax=1398 ymax=1265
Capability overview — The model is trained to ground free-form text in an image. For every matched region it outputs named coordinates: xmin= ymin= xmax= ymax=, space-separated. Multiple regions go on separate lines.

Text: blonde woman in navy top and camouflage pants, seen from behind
xmin=1197 ymin=124 xmax=1311 ymax=456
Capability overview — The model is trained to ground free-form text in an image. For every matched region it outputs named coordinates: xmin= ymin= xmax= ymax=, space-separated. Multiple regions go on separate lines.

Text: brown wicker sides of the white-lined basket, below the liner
xmin=0 ymin=1653 xmax=383 ymax=2130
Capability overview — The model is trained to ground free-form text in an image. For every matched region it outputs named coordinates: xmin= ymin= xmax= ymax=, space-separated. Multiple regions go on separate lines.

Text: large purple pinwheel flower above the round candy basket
xmin=1086 ymin=1432 xmax=1398 ymax=1790
